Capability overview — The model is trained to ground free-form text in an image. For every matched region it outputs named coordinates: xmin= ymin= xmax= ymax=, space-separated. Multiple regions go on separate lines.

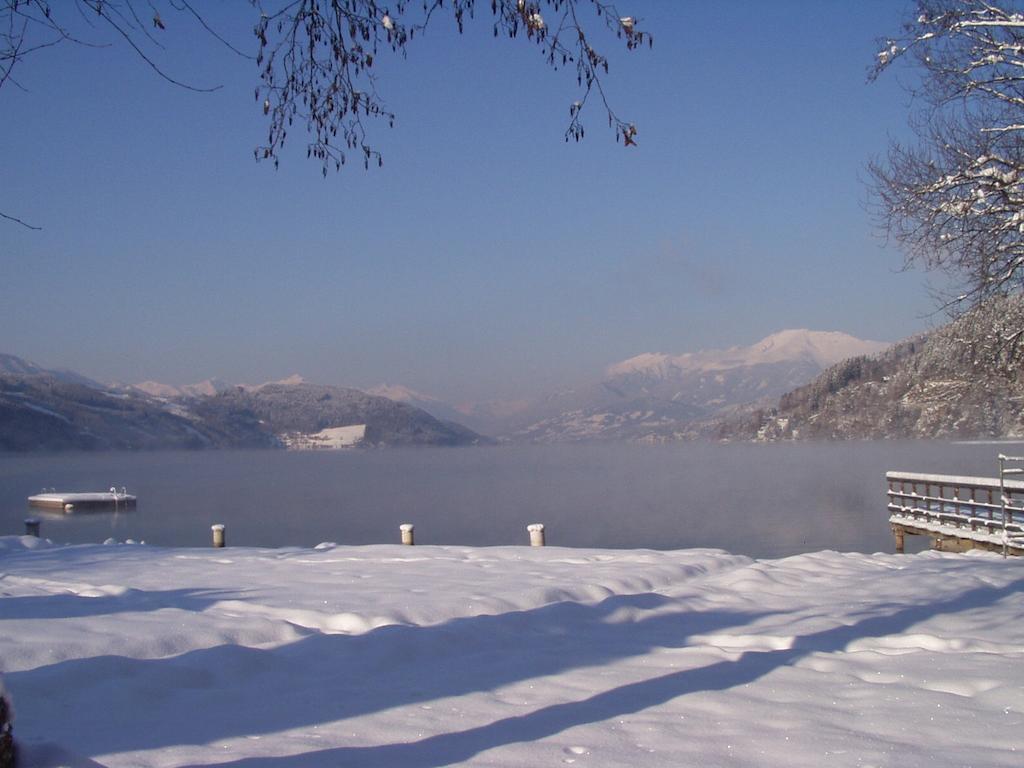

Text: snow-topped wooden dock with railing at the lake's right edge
xmin=886 ymin=457 xmax=1024 ymax=555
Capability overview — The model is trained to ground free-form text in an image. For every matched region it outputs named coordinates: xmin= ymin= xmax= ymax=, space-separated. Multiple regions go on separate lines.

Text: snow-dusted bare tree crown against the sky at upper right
xmin=870 ymin=0 xmax=1024 ymax=334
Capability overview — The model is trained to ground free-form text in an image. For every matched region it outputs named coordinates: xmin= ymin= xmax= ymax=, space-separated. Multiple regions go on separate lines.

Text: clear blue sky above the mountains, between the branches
xmin=0 ymin=0 xmax=939 ymax=401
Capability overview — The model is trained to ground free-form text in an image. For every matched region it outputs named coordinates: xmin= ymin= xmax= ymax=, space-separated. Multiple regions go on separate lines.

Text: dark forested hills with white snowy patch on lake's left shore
xmin=0 ymin=354 xmax=488 ymax=451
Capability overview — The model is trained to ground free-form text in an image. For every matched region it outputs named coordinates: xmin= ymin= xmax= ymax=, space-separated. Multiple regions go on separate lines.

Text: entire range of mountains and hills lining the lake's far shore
xmin=0 ymin=311 xmax=1024 ymax=451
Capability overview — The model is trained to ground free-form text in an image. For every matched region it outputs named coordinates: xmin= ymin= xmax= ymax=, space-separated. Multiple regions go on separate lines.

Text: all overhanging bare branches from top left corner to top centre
xmin=0 ymin=0 xmax=651 ymax=228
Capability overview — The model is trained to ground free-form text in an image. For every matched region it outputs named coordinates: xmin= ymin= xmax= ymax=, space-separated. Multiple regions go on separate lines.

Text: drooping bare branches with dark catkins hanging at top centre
xmin=254 ymin=0 xmax=651 ymax=175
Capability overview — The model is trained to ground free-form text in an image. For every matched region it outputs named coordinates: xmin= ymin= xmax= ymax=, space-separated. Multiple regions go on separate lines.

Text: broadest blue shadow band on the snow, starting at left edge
xmin=12 ymin=593 xmax=764 ymax=755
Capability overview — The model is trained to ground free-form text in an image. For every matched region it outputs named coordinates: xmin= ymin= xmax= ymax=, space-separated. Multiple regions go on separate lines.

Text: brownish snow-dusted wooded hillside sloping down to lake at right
xmin=712 ymin=296 xmax=1024 ymax=441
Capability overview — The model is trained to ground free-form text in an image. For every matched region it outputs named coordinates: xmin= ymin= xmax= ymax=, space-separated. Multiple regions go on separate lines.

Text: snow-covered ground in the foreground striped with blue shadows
xmin=0 ymin=538 xmax=1024 ymax=768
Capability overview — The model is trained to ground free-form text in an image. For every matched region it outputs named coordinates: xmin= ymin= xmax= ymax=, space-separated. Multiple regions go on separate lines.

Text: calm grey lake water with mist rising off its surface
xmin=0 ymin=442 xmax=1024 ymax=557
